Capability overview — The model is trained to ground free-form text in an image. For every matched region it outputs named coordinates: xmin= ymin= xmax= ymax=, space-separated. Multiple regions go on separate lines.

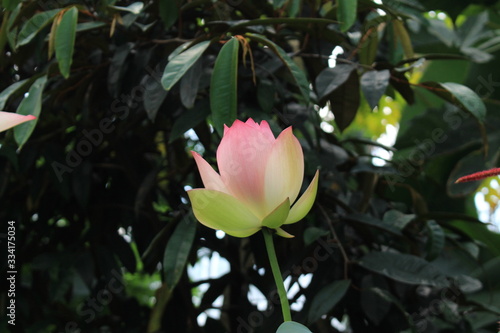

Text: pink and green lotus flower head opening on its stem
xmin=188 ymin=119 xmax=318 ymax=237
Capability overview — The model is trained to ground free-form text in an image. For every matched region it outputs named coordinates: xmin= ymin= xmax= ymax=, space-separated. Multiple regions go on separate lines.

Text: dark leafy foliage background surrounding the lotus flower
xmin=0 ymin=0 xmax=500 ymax=332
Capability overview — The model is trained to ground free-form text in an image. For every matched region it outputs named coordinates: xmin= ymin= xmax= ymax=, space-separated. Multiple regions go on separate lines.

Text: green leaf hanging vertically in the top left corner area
xmin=55 ymin=7 xmax=78 ymax=78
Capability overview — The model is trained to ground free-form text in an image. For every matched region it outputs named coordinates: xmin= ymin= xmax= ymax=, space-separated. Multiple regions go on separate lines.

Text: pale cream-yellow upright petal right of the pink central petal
xmin=264 ymin=127 xmax=304 ymax=211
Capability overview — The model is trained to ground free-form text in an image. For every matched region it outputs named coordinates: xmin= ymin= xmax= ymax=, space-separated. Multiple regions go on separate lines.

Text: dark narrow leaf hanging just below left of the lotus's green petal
xmin=163 ymin=212 xmax=198 ymax=290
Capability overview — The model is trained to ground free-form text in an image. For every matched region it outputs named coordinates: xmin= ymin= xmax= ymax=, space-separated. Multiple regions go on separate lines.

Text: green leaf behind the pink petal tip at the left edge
xmin=14 ymin=76 xmax=47 ymax=147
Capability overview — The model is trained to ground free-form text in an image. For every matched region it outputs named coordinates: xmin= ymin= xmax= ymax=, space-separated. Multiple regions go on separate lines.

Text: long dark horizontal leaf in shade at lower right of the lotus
xmin=359 ymin=252 xmax=449 ymax=287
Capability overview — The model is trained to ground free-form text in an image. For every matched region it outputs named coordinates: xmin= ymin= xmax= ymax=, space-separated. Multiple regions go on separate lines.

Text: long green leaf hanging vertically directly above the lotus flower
xmin=210 ymin=38 xmax=240 ymax=134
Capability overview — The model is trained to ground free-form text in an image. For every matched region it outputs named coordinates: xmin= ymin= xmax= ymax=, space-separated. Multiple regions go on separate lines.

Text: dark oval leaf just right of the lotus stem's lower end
xmin=307 ymin=280 xmax=351 ymax=324
